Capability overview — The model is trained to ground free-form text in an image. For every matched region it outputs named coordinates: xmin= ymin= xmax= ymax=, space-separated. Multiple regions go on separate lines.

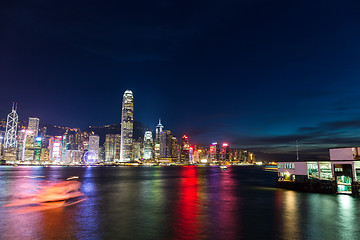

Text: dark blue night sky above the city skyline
xmin=0 ymin=0 xmax=360 ymax=160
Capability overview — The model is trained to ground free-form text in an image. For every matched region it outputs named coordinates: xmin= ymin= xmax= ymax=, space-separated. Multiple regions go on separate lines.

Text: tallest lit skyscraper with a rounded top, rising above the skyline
xmin=120 ymin=90 xmax=134 ymax=162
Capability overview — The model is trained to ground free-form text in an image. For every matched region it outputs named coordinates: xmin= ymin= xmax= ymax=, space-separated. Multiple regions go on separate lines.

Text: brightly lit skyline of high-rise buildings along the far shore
xmin=0 ymin=90 xmax=255 ymax=165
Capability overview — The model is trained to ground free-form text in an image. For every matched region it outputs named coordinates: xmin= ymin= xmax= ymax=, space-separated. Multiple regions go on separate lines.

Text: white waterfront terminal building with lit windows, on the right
xmin=277 ymin=147 xmax=360 ymax=196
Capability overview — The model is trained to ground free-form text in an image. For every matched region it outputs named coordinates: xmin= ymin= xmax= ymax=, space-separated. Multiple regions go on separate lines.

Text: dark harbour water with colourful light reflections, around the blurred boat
xmin=0 ymin=166 xmax=360 ymax=239
